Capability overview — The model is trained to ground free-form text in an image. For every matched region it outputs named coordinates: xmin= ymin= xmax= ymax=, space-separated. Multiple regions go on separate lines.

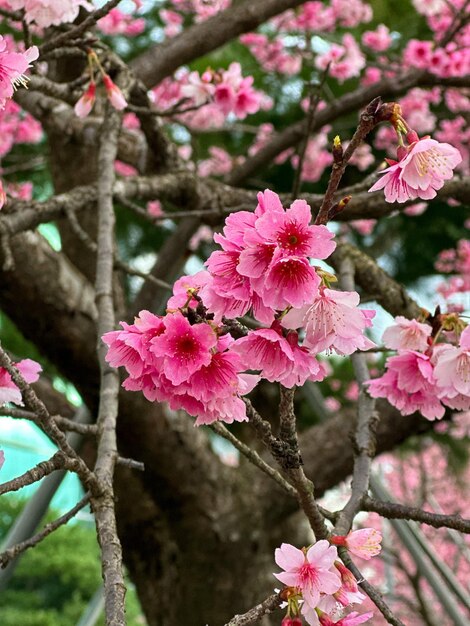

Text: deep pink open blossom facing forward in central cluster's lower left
xmin=151 ymin=312 xmax=217 ymax=385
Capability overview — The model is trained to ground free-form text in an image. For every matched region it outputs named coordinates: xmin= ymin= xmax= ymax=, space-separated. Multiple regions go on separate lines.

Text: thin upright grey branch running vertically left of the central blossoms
xmin=92 ymin=103 xmax=126 ymax=626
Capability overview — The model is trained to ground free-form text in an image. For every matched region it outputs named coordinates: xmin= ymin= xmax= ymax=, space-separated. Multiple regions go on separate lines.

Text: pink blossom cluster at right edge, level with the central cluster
xmin=368 ymin=316 xmax=470 ymax=420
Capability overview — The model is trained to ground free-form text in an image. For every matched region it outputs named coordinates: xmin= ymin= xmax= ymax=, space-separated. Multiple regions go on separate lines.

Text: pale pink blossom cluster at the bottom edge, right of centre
xmin=274 ymin=528 xmax=382 ymax=626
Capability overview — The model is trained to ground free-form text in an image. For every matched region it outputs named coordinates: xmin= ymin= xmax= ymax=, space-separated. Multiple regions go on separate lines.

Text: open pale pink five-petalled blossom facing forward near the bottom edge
xmin=274 ymin=539 xmax=341 ymax=609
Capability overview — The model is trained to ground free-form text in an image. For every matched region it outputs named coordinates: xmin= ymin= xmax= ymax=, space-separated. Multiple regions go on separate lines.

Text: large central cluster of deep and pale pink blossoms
xmin=103 ymin=190 xmax=374 ymax=425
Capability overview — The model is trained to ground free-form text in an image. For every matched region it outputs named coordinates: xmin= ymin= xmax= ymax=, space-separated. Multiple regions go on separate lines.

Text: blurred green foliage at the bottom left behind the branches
xmin=0 ymin=496 xmax=143 ymax=626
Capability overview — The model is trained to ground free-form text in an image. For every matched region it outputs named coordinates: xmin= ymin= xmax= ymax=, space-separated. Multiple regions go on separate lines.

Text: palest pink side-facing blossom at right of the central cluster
xmin=282 ymin=288 xmax=375 ymax=354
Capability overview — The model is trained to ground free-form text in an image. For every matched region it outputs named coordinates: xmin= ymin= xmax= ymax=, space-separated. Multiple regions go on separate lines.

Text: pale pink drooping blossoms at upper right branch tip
xmin=369 ymin=131 xmax=462 ymax=202
